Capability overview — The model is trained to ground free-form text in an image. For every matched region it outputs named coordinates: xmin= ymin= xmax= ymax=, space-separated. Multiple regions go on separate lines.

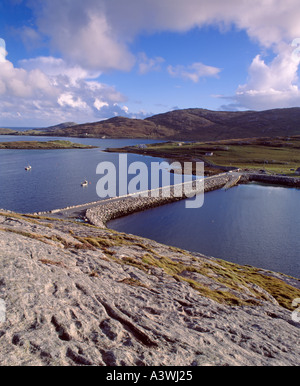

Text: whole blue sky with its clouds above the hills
xmin=0 ymin=0 xmax=300 ymax=127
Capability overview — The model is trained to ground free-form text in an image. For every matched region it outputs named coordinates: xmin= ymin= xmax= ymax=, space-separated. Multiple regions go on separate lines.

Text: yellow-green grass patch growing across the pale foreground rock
xmin=68 ymin=228 xmax=300 ymax=310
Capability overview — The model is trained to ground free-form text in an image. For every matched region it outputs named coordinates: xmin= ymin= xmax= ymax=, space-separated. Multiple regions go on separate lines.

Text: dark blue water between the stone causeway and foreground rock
xmin=109 ymin=184 xmax=300 ymax=278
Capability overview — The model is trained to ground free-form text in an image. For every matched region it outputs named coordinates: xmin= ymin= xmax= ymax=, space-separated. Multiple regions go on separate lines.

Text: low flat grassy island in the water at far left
xmin=0 ymin=140 xmax=96 ymax=150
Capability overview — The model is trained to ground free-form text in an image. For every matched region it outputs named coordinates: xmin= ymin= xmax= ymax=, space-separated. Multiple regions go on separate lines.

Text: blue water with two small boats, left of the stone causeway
xmin=0 ymin=136 xmax=166 ymax=213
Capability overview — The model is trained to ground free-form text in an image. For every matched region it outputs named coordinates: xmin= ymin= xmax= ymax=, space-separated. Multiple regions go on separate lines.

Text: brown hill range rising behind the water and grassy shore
xmin=28 ymin=107 xmax=300 ymax=141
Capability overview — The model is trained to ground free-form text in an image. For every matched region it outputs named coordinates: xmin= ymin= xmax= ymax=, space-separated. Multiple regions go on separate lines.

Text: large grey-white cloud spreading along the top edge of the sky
xmin=30 ymin=0 xmax=300 ymax=70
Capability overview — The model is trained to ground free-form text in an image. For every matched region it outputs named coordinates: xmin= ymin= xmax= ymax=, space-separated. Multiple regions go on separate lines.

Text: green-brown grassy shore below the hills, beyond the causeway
xmin=112 ymin=136 xmax=300 ymax=175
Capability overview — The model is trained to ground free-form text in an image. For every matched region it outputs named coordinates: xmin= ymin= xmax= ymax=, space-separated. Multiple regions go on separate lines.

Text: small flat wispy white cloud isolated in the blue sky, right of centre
xmin=168 ymin=63 xmax=221 ymax=83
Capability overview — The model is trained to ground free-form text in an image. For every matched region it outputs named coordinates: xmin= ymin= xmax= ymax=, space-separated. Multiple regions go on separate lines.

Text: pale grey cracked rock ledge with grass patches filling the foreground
xmin=0 ymin=212 xmax=300 ymax=366
